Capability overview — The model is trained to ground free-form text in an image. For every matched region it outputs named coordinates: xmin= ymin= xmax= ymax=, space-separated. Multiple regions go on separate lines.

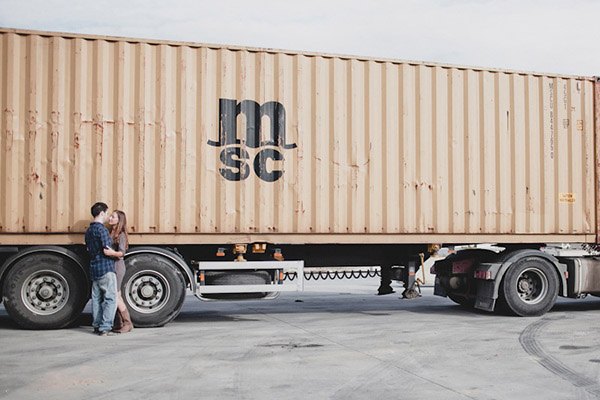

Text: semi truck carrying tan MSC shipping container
xmin=0 ymin=28 xmax=600 ymax=329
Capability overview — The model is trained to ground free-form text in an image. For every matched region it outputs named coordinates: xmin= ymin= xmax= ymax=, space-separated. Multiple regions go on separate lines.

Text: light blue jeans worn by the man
xmin=92 ymin=272 xmax=117 ymax=332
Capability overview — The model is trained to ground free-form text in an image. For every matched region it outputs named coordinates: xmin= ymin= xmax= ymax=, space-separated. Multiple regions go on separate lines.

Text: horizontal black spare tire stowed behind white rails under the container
xmin=202 ymin=271 xmax=271 ymax=300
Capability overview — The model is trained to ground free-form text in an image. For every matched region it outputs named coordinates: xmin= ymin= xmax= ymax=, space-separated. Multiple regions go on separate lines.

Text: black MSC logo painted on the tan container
xmin=208 ymin=99 xmax=297 ymax=182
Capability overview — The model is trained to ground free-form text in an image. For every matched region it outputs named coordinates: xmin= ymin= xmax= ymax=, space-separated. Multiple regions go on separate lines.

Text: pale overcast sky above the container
xmin=0 ymin=0 xmax=600 ymax=76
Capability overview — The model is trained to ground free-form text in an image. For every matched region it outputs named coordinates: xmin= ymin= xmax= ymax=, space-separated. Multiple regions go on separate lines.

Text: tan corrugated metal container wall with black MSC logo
xmin=0 ymin=30 xmax=596 ymax=243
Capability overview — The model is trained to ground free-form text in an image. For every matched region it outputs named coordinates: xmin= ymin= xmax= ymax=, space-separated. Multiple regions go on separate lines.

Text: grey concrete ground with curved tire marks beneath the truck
xmin=0 ymin=279 xmax=600 ymax=400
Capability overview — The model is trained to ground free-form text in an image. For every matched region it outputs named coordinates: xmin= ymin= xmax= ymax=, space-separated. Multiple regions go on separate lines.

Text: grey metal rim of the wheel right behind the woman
xmin=125 ymin=270 xmax=171 ymax=314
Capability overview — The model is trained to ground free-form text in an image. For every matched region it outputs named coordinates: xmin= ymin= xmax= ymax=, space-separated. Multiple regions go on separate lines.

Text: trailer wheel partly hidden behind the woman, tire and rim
xmin=123 ymin=254 xmax=186 ymax=328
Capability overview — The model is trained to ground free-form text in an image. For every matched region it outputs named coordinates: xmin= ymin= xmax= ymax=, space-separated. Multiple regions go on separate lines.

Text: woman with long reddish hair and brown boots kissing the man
xmin=108 ymin=210 xmax=133 ymax=333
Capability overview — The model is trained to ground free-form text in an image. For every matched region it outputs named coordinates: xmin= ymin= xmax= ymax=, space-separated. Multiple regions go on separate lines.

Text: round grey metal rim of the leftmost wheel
xmin=21 ymin=270 xmax=69 ymax=315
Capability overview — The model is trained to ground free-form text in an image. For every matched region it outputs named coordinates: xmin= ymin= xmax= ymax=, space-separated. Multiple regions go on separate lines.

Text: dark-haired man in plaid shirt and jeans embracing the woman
xmin=85 ymin=203 xmax=118 ymax=336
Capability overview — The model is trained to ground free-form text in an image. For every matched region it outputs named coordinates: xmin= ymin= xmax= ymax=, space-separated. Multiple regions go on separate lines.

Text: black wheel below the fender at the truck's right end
xmin=498 ymin=257 xmax=559 ymax=317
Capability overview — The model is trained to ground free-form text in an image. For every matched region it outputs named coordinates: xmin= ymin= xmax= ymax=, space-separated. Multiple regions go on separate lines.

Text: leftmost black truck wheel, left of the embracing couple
xmin=3 ymin=253 xmax=89 ymax=329
